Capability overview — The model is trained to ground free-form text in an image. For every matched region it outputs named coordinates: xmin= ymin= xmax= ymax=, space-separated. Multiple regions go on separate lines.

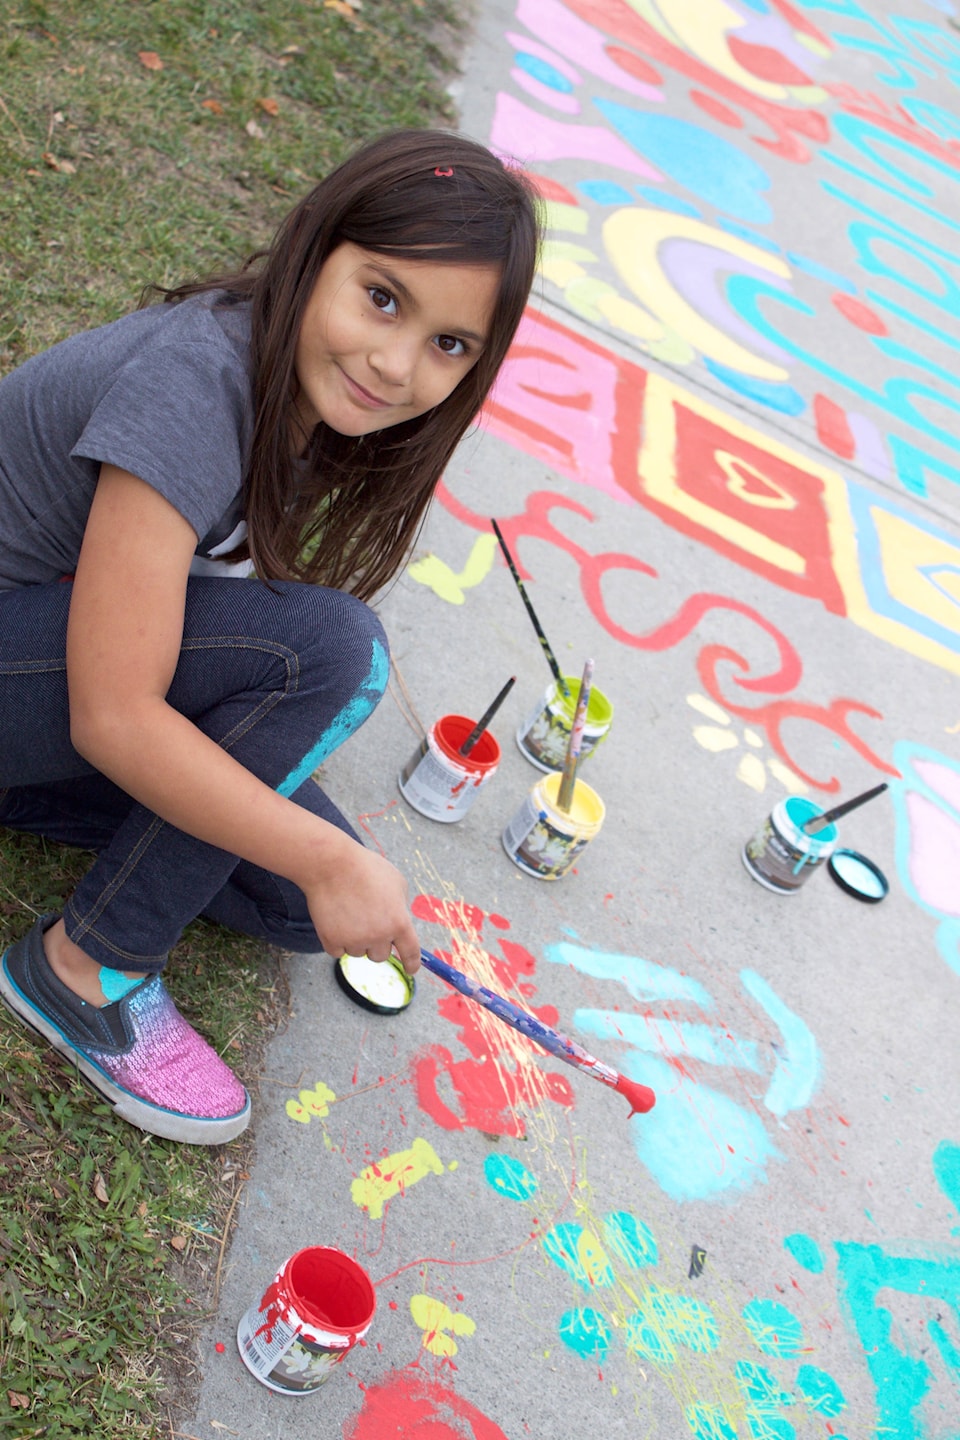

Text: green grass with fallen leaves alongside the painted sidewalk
xmin=0 ymin=0 xmax=462 ymax=1440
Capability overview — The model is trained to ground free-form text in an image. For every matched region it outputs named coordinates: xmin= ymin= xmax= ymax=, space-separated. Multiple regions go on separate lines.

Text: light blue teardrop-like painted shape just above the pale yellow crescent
xmin=594 ymin=99 xmax=773 ymax=225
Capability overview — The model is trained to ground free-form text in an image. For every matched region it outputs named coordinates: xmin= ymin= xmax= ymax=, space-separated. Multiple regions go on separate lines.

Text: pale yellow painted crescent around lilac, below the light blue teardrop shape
xmin=603 ymin=206 xmax=790 ymax=382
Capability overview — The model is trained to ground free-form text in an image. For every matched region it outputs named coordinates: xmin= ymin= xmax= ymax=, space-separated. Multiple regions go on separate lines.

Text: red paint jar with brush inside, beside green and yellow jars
xmin=397 ymin=716 xmax=499 ymax=825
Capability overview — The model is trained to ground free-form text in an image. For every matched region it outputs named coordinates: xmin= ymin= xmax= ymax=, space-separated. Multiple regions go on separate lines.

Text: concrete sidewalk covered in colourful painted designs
xmin=184 ymin=0 xmax=960 ymax=1440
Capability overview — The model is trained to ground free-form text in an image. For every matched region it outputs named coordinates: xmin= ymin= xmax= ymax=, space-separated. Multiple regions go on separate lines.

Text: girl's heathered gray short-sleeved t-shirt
xmin=0 ymin=295 xmax=253 ymax=590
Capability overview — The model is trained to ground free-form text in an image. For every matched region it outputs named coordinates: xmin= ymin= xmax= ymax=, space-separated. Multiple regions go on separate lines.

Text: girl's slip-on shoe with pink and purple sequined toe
xmin=0 ymin=914 xmax=250 ymax=1145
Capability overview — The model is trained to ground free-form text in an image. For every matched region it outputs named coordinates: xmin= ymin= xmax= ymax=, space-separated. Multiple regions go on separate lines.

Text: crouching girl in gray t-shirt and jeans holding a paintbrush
xmin=0 ymin=131 xmax=537 ymax=1143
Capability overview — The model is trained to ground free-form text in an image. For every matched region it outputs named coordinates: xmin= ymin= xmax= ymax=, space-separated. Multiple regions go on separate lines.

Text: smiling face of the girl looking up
xmin=294 ymin=242 xmax=499 ymax=449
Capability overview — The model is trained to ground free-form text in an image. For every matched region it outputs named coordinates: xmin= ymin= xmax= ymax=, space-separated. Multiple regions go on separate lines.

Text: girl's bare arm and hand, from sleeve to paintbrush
xmin=66 ymin=465 xmax=420 ymax=971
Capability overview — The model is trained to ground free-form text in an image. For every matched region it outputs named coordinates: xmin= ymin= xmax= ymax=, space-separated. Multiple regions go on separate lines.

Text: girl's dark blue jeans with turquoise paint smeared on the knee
xmin=0 ymin=577 xmax=389 ymax=971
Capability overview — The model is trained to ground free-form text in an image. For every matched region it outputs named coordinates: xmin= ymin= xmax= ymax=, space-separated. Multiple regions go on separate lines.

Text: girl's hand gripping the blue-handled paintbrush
xmin=301 ymin=831 xmax=420 ymax=975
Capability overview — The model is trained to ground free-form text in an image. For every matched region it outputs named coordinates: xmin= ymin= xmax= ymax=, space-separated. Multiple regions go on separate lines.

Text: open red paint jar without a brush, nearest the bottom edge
xmin=236 ymin=1246 xmax=377 ymax=1395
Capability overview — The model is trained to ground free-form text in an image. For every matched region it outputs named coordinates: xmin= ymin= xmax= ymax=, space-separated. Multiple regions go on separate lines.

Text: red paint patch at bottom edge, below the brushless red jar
xmin=344 ymin=1365 xmax=507 ymax=1440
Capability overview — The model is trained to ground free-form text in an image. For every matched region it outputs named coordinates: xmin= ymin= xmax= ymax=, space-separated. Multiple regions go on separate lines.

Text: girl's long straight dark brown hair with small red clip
xmin=156 ymin=130 xmax=540 ymax=599
